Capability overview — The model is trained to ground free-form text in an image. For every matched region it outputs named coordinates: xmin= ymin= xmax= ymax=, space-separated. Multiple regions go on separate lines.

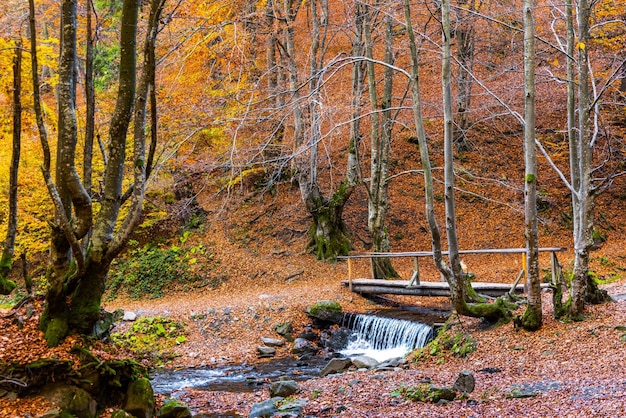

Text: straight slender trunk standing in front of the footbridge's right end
xmin=520 ymin=0 xmax=542 ymax=331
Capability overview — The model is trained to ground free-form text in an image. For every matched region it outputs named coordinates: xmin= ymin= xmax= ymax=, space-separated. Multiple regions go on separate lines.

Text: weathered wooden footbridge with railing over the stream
xmin=338 ymin=247 xmax=565 ymax=296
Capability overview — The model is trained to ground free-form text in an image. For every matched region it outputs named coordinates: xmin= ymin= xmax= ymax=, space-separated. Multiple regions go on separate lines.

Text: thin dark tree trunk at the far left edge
xmin=0 ymin=42 xmax=22 ymax=295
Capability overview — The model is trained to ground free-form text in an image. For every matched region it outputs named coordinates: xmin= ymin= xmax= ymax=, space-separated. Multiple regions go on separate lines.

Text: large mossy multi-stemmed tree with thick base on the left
xmin=31 ymin=0 xmax=165 ymax=346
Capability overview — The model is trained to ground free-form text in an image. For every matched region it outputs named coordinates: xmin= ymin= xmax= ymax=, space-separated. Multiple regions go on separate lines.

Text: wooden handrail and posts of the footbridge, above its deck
xmin=337 ymin=247 xmax=565 ymax=290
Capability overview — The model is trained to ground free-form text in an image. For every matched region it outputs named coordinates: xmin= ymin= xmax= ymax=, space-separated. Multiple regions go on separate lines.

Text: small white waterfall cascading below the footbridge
xmin=340 ymin=315 xmax=433 ymax=361
